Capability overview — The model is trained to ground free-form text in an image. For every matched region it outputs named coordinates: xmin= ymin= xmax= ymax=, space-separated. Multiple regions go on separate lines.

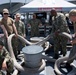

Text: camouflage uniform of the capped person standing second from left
xmin=14 ymin=20 xmax=25 ymax=54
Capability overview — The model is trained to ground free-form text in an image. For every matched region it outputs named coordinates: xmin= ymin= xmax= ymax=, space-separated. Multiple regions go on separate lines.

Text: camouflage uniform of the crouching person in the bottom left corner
xmin=0 ymin=47 xmax=13 ymax=75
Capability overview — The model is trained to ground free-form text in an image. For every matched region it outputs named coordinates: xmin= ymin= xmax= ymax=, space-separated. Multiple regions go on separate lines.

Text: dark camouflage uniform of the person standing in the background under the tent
xmin=29 ymin=19 xmax=41 ymax=37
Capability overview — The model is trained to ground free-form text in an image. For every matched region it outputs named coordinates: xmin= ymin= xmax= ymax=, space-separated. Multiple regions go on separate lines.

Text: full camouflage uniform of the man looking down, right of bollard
xmin=52 ymin=13 xmax=69 ymax=56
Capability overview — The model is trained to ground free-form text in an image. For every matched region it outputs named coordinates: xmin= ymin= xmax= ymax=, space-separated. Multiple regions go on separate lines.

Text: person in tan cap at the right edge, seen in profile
xmin=66 ymin=9 xmax=76 ymax=66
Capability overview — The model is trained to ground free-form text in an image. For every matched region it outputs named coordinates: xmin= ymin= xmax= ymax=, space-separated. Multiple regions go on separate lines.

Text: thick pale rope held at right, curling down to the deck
xmin=54 ymin=32 xmax=76 ymax=75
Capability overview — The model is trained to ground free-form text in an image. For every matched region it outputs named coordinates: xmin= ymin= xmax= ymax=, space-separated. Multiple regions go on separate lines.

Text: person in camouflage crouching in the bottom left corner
xmin=0 ymin=40 xmax=13 ymax=75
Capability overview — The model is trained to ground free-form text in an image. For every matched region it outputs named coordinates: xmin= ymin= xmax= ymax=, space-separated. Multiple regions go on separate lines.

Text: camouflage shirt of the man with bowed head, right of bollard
xmin=52 ymin=13 xmax=70 ymax=32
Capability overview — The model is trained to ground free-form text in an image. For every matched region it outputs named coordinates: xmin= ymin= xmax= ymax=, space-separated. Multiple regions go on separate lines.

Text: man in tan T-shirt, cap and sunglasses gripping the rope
xmin=0 ymin=8 xmax=18 ymax=50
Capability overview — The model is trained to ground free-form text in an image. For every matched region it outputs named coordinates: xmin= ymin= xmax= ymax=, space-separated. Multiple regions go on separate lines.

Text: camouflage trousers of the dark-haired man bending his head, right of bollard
xmin=54 ymin=36 xmax=68 ymax=56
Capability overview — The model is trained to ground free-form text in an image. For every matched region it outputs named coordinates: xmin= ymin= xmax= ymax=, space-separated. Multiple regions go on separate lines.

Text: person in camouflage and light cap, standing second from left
xmin=14 ymin=13 xmax=26 ymax=54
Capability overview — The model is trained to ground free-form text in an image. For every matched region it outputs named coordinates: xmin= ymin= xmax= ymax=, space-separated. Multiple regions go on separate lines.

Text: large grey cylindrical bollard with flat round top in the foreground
xmin=22 ymin=45 xmax=43 ymax=68
